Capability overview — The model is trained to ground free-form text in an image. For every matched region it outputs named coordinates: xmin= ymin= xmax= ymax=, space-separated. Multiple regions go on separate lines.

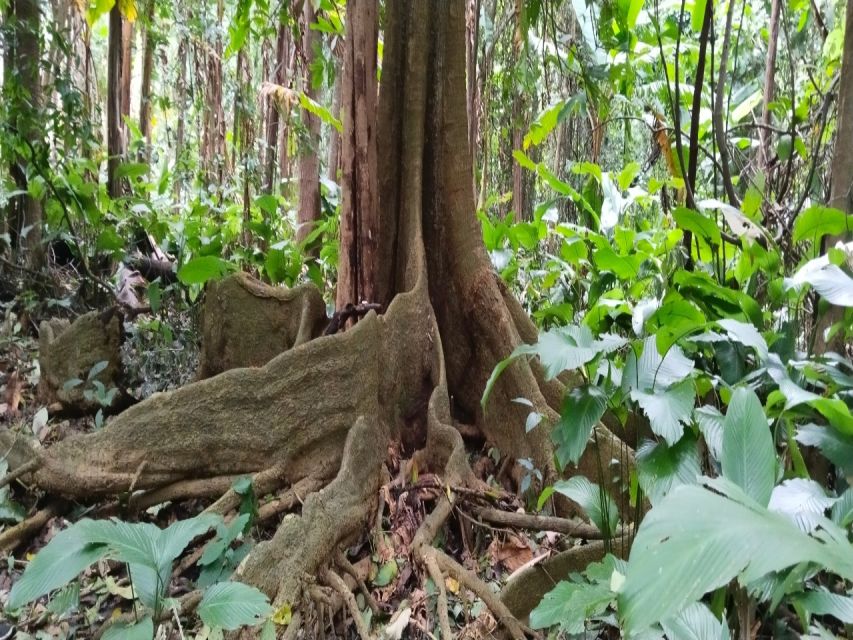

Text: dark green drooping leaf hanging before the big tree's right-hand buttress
xmin=551 ymin=385 xmax=607 ymax=467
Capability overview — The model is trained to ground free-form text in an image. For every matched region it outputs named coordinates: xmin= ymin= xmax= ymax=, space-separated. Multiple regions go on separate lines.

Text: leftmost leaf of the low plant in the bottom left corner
xmin=6 ymin=520 xmax=107 ymax=610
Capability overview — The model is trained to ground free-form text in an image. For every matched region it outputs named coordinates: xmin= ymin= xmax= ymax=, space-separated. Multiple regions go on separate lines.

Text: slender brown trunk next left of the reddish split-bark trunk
xmin=296 ymin=2 xmax=320 ymax=242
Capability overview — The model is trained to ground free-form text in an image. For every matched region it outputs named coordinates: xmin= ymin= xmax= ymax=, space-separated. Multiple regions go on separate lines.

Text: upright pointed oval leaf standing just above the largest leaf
xmin=720 ymin=387 xmax=776 ymax=506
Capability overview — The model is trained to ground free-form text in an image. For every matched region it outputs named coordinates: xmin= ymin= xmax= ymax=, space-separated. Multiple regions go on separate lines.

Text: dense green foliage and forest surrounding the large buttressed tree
xmin=0 ymin=0 xmax=853 ymax=638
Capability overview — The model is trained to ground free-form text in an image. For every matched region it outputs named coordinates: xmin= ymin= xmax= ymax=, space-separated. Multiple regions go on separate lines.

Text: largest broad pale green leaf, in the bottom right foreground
xmin=619 ymin=479 xmax=853 ymax=633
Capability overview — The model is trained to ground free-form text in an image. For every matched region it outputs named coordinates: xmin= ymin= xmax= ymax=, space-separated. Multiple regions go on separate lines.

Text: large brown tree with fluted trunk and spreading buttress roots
xmin=0 ymin=0 xmax=630 ymax=637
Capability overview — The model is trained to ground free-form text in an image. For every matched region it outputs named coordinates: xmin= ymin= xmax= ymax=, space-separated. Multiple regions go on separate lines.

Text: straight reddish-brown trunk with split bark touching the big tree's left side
xmin=336 ymin=0 xmax=378 ymax=309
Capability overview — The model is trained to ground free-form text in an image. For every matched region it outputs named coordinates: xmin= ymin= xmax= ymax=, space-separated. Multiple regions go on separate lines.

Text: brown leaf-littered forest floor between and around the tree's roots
xmin=0 ymin=304 xmax=600 ymax=639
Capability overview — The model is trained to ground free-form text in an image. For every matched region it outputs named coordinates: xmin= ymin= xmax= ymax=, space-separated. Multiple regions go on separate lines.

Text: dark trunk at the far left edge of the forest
xmin=3 ymin=0 xmax=47 ymax=269
